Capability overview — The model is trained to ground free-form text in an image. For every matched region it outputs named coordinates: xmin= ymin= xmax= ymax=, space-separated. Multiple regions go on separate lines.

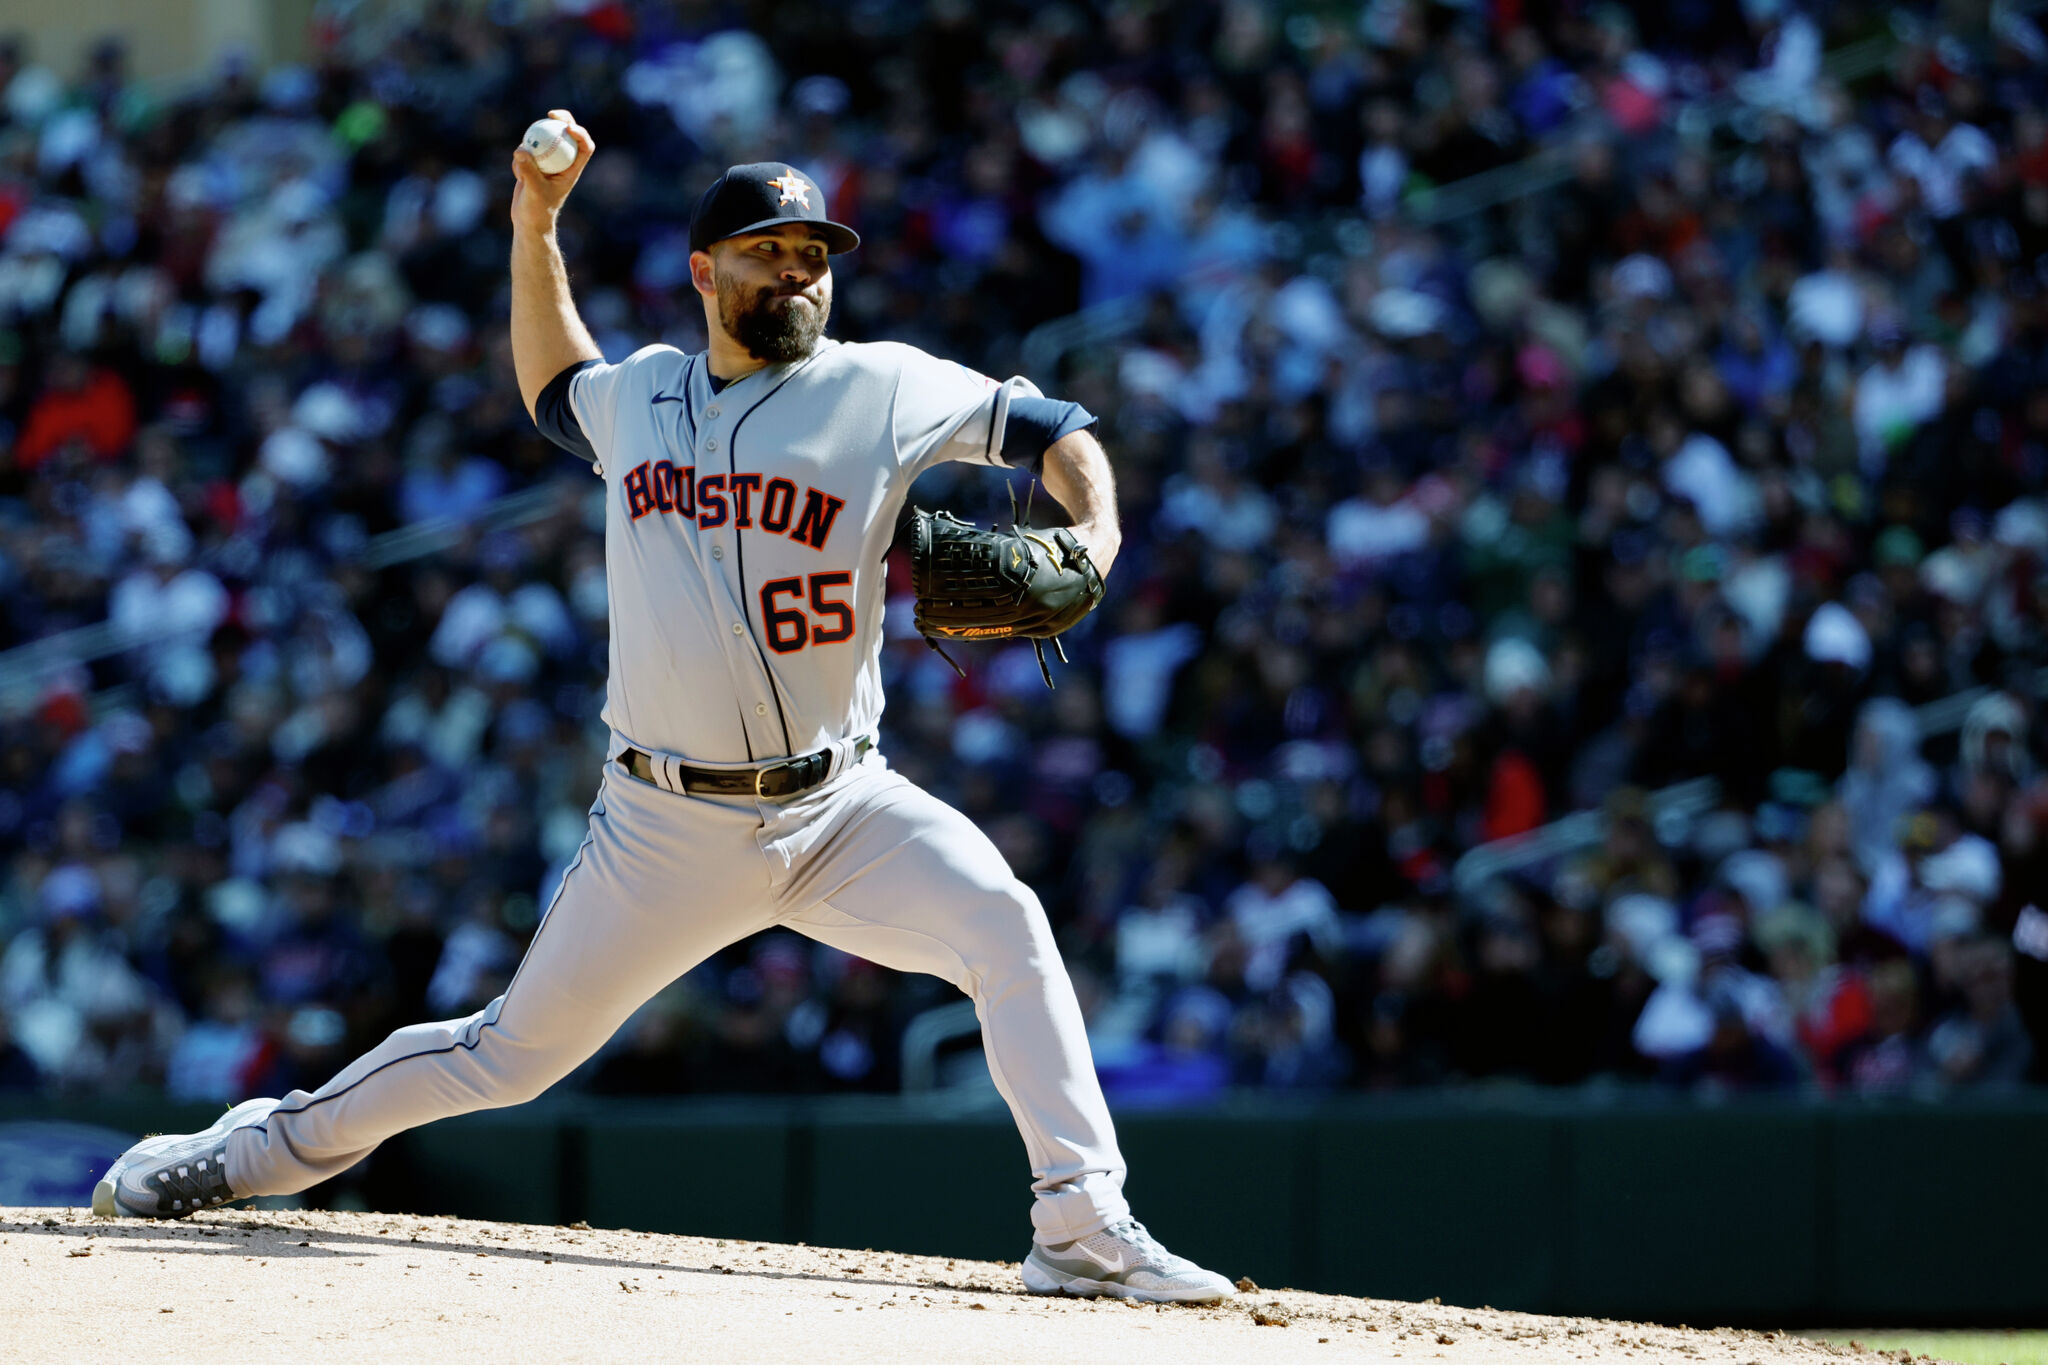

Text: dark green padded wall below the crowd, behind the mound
xmin=16 ymin=1095 xmax=2048 ymax=1326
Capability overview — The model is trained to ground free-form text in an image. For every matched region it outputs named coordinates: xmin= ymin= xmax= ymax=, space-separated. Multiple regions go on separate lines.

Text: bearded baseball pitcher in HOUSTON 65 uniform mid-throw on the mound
xmin=92 ymin=111 xmax=1231 ymax=1302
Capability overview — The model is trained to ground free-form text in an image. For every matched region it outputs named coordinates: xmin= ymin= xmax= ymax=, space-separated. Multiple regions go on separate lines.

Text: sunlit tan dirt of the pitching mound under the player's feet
xmin=0 ymin=1209 xmax=1855 ymax=1365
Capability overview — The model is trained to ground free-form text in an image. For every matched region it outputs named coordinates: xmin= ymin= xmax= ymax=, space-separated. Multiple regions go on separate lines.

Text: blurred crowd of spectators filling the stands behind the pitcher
xmin=0 ymin=0 xmax=2048 ymax=1105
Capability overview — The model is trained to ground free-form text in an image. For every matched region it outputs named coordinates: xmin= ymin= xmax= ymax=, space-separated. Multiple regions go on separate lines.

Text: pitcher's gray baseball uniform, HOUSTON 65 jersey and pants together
xmin=227 ymin=340 xmax=1128 ymax=1244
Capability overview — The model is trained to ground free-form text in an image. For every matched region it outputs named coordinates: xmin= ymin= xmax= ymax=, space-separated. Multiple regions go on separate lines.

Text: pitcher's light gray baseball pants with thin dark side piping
xmin=227 ymin=755 xmax=1128 ymax=1242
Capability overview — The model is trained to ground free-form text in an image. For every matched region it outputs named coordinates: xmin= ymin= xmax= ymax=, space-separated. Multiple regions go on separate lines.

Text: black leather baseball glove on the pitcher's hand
xmin=897 ymin=508 xmax=1102 ymax=688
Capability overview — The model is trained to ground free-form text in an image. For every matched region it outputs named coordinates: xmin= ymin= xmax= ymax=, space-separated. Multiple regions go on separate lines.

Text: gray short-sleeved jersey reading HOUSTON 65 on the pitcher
xmin=569 ymin=340 xmax=1038 ymax=763
